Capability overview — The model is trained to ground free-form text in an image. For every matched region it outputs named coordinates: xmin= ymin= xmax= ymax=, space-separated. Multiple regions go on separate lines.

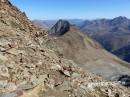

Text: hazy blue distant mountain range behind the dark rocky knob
xmin=33 ymin=16 xmax=130 ymax=62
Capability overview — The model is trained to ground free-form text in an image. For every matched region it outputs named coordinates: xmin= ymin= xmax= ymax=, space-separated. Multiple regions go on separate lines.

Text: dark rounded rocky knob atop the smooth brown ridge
xmin=49 ymin=20 xmax=70 ymax=36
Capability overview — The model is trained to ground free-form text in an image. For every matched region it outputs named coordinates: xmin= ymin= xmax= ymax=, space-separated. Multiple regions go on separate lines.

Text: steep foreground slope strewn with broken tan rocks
xmin=0 ymin=0 xmax=130 ymax=97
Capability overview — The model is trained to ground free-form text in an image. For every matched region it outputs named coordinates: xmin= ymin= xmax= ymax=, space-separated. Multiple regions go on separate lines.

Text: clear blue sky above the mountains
xmin=10 ymin=0 xmax=130 ymax=20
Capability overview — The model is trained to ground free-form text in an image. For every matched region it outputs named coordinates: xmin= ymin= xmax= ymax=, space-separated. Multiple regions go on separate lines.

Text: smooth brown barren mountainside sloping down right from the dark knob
xmin=46 ymin=20 xmax=130 ymax=80
